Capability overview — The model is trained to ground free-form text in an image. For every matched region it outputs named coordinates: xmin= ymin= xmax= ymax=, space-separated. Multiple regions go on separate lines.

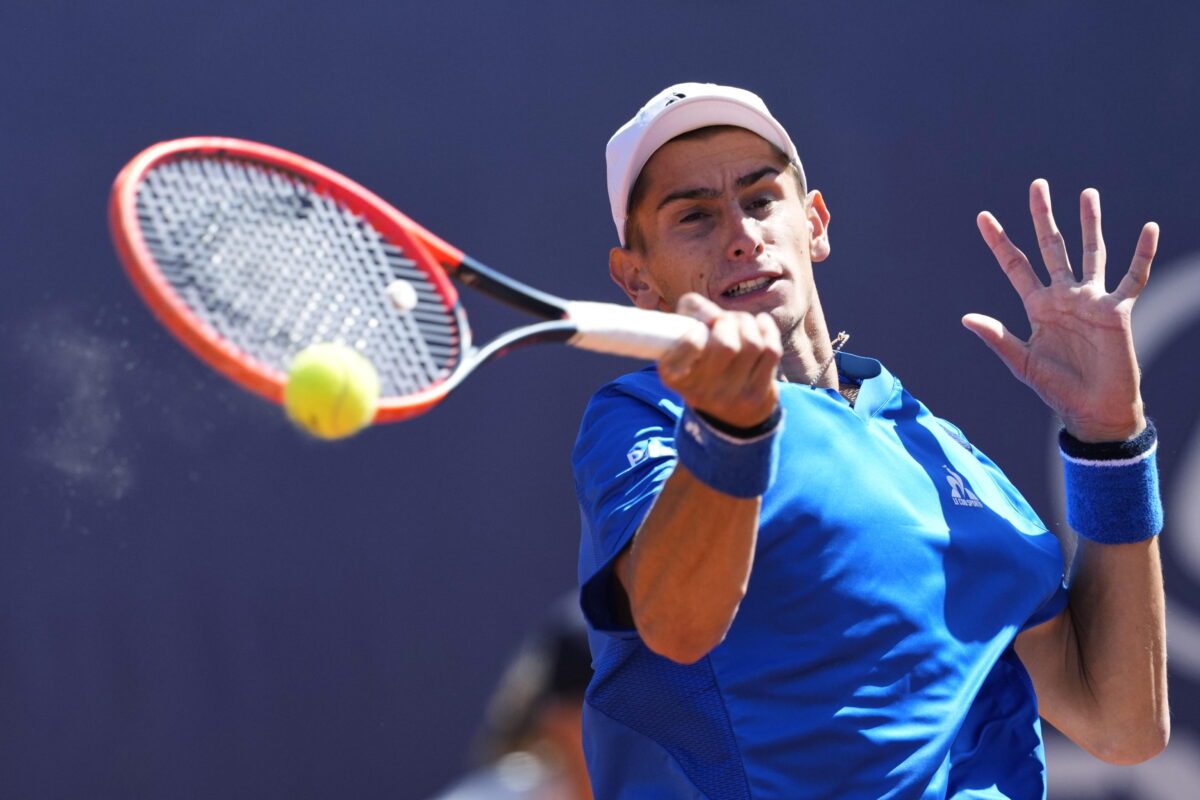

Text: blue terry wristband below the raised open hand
xmin=1058 ymin=420 xmax=1163 ymax=545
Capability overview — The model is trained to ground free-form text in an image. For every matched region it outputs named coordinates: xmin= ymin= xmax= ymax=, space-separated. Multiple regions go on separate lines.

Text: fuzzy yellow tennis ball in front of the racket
xmin=283 ymin=342 xmax=379 ymax=439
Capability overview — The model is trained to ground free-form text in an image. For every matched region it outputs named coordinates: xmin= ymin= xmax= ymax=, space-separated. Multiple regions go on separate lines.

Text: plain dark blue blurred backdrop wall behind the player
xmin=0 ymin=0 xmax=1200 ymax=800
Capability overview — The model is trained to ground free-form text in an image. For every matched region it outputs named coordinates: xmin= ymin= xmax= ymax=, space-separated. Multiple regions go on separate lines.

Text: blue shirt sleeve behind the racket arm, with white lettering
xmin=572 ymin=371 xmax=682 ymax=638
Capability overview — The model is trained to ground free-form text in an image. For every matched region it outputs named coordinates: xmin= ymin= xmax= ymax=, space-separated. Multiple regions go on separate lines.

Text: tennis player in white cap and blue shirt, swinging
xmin=574 ymin=84 xmax=1169 ymax=800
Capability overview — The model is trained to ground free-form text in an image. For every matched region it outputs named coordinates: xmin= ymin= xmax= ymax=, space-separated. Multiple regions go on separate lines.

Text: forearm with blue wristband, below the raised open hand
xmin=1019 ymin=429 xmax=1170 ymax=763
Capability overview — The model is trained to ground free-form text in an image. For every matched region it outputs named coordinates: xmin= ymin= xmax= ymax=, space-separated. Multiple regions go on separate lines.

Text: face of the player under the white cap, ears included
xmin=611 ymin=128 xmax=828 ymax=345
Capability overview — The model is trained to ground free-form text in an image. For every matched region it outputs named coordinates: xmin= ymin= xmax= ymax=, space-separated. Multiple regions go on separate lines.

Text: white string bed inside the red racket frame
xmin=137 ymin=156 xmax=469 ymax=397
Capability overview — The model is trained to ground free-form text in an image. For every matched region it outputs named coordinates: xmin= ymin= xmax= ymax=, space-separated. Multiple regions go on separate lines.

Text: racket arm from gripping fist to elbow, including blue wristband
xmin=616 ymin=293 xmax=782 ymax=663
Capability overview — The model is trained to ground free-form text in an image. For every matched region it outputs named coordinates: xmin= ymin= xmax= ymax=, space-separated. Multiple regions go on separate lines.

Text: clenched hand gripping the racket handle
xmin=659 ymin=295 xmax=782 ymax=427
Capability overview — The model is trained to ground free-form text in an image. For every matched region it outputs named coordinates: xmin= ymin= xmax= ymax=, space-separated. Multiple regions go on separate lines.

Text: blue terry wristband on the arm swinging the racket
xmin=674 ymin=408 xmax=784 ymax=498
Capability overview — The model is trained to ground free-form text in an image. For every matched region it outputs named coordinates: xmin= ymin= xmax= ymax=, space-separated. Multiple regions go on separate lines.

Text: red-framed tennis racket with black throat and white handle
xmin=109 ymin=137 xmax=701 ymax=422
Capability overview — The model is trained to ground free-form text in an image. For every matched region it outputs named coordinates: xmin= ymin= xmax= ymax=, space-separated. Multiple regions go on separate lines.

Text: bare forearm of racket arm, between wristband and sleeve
xmin=616 ymin=465 xmax=760 ymax=663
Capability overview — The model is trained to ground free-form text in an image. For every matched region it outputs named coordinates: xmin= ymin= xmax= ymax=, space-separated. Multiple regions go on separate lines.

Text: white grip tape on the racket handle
xmin=566 ymin=300 xmax=708 ymax=361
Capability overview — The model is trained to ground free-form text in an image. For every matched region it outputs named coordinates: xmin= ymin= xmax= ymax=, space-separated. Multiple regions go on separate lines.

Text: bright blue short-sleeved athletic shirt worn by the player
xmin=574 ymin=354 xmax=1067 ymax=800
